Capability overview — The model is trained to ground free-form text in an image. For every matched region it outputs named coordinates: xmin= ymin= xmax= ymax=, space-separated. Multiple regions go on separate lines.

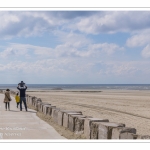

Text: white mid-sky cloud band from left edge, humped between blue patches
xmin=0 ymin=32 xmax=124 ymax=59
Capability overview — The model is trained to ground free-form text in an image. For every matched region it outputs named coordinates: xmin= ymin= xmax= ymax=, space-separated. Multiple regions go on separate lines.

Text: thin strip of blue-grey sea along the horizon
xmin=0 ymin=84 xmax=150 ymax=90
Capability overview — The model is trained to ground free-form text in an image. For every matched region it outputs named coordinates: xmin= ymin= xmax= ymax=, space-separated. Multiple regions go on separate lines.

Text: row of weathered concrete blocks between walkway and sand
xmin=1 ymin=91 xmax=150 ymax=139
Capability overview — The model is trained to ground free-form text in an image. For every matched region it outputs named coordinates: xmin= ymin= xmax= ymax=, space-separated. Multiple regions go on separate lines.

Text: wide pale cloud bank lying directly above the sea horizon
xmin=0 ymin=57 xmax=150 ymax=83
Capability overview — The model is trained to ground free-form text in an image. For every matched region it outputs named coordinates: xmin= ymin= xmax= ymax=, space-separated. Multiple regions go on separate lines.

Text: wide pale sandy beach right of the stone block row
xmin=27 ymin=90 xmax=150 ymax=135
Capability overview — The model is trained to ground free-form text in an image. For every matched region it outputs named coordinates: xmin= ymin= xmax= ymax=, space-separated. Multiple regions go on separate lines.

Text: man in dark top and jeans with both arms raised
xmin=17 ymin=81 xmax=27 ymax=111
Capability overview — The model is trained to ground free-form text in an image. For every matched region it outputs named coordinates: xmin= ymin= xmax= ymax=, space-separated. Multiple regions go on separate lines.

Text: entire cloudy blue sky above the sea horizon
xmin=0 ymin=10 xmax=150 ymax=84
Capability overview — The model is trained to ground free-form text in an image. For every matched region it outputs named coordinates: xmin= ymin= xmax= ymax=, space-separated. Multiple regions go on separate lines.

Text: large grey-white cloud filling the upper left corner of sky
xmin=0 ymin=11 xmax=65 ymax=39
